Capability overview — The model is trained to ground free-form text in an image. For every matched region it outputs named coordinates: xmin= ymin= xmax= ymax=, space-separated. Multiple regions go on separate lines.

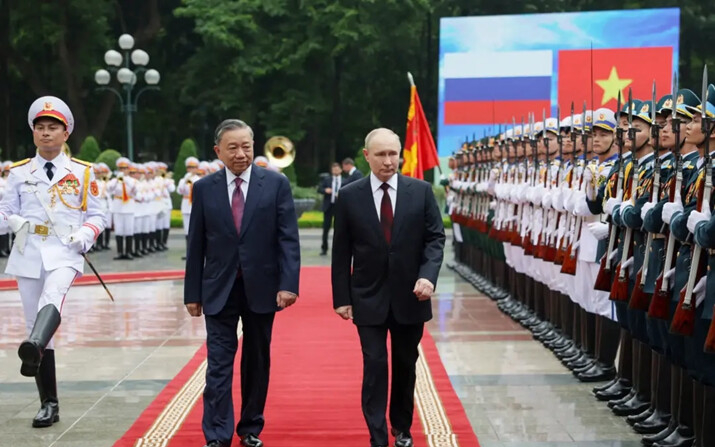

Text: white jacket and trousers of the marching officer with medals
xmin=0 ymin=153 xmax=105 ymax=347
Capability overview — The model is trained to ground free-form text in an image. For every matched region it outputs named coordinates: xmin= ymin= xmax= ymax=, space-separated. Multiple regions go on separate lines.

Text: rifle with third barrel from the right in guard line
xmin=628 ymin=81 xmax=661 ymax=311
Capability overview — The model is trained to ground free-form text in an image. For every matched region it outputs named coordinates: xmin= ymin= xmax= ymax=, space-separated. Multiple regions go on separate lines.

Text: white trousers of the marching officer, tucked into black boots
xmin=17 ymin=267 xmax=79 ymax=349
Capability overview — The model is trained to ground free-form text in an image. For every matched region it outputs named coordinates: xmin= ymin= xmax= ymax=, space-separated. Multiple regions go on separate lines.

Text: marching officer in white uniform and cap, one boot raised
xmin=0 ymin=96 xmax=105 ymax=427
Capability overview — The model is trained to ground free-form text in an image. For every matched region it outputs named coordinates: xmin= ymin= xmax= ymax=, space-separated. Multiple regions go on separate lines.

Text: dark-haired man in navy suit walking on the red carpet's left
xmin=184 ymin=120 xmax=300 ymax=447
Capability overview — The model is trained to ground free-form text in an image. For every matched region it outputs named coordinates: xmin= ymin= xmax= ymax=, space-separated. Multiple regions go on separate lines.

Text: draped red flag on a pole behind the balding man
xmin=402 ymin=85 xmax=439 ymax=179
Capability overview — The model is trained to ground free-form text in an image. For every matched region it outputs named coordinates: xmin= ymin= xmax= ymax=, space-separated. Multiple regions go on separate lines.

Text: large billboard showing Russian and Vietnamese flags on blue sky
xmin=437 ymin=8 xmax=680 ymax=156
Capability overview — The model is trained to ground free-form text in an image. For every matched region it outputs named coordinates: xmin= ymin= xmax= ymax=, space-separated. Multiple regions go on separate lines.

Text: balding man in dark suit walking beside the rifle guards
xmin=332 ymin=129 xmax=445 ymax=447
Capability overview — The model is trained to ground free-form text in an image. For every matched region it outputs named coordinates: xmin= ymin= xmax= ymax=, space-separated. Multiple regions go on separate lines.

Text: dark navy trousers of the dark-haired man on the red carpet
xmin=202 ymin=278 xmax=275 ymax=445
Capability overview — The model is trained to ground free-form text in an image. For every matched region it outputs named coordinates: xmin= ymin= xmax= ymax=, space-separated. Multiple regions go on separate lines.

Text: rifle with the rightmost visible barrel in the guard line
xmin=670 ymin=65 xmax=713 ymax=337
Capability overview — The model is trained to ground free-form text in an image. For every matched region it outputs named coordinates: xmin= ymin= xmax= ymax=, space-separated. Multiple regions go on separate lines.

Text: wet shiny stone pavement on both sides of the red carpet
xmin=0 ymin=230 xmax=640 ymax=447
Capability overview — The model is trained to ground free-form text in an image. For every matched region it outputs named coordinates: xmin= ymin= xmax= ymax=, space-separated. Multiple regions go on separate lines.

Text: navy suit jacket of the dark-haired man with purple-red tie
xmin=184 ymin=165 xmax=300 ymax=315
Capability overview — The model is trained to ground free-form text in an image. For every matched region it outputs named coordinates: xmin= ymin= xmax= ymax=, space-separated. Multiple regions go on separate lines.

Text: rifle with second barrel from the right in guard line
xmin=648 ymin=73 xmax=683 ymax=320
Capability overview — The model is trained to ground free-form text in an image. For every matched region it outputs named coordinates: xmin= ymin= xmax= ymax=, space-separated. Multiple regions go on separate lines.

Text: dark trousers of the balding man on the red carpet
xmin=357 ymin=313 xmax=424 ymax=446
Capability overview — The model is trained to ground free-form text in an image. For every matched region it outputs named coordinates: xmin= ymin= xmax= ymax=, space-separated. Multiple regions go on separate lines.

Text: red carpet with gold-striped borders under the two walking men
xmin=114 ymin=267 xmax=479 ymax=447
